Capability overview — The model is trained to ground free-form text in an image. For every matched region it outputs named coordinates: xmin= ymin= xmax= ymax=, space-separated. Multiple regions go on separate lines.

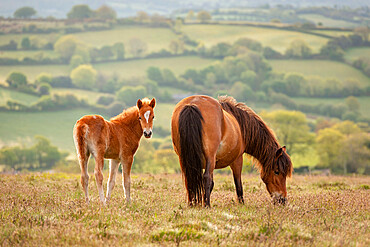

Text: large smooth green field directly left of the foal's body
xmin=0 ymin=109 xmax=98 ymax=152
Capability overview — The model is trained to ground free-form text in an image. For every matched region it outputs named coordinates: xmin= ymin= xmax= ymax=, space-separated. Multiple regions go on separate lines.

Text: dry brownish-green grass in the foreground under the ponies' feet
xmin=0 ymin=171 xmax=370 ymax=246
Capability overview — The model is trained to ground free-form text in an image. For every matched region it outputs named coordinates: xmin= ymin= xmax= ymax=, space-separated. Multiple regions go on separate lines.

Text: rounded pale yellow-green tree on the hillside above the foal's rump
xmin=71 ymin=64 xmax=97 ymax=89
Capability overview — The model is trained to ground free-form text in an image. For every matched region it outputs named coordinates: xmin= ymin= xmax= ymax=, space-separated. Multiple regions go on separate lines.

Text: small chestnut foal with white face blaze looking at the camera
xmin=73 ymin=98 xmax=155 ymax=205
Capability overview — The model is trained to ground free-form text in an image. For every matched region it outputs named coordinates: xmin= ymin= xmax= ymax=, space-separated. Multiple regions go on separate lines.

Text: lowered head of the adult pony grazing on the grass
xmin=261 ymin=146 xmax=293 ymax=204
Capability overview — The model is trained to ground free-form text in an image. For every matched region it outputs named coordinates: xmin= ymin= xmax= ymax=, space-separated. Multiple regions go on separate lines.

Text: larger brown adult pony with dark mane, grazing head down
xmin=171 ymin=96 xmax=293 ymax=206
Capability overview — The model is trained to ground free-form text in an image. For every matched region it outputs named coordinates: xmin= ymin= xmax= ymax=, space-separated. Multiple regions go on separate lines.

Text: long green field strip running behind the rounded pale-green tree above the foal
xmin=0 ymin=56 xmax=215 ymax=81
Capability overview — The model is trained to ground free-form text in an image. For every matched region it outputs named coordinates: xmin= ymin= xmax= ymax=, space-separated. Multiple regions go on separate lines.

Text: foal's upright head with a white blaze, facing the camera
xmin=136 ymin=98 xmax=155 ymax=138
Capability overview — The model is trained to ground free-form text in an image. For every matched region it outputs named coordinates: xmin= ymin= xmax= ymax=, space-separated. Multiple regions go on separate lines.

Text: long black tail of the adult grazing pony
xmin=179 ymin=105 xmax=204 ymax=205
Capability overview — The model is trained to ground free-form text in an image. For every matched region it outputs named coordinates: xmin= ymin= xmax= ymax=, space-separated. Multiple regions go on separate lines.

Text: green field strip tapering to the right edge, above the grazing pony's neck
xmin=269 ymin=60 xmax=370 ymax=86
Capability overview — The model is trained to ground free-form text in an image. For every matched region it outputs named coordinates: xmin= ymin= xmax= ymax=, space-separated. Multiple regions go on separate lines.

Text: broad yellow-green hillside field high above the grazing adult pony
xmin=182 ymin=25 xmax=328 ymax=53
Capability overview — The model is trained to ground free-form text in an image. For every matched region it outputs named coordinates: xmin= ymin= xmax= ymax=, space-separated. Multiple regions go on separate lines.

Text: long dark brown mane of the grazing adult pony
xmin=218 ymin=96 xmax=292 ymax=177
